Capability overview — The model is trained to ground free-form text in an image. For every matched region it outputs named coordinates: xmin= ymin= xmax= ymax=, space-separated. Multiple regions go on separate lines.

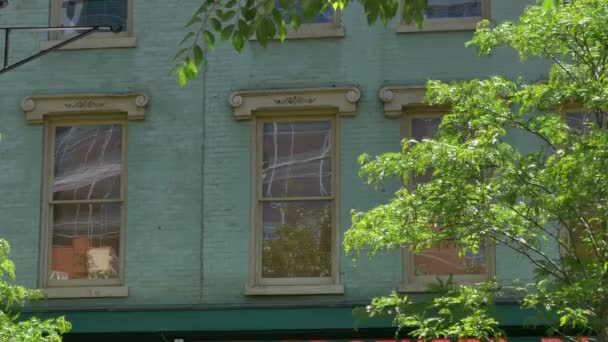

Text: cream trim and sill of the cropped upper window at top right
xmin=397 ymin=0 xmax=492 ymax=33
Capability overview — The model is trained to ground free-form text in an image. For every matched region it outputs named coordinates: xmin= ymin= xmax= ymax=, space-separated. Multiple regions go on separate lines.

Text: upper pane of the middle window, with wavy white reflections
xmin=262 ymin=121 xmax=333 ymax=197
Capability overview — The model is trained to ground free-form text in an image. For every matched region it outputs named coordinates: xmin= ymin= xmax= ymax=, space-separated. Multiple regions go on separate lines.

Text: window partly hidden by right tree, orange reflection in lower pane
xmin=403 ymin=107 xmax=493 ymax=292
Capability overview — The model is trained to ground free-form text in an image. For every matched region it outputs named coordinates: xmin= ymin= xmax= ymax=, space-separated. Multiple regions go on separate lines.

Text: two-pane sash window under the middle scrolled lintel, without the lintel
xmin=256 ymin=117 xmax=336 ymax=285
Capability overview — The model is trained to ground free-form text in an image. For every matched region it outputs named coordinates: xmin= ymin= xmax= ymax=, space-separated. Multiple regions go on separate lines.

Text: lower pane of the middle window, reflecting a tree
xmin=262 ymin=201 xmax=332 ymax=278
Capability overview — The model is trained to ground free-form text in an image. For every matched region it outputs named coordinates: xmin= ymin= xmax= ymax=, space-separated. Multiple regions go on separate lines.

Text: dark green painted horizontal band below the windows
xmin=23 ymin=304 xmax=544 ymax=333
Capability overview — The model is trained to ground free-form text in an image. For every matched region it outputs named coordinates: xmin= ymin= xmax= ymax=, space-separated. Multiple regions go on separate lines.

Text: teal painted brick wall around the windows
xmin=0 ymin=0 xmax=546 ymax=316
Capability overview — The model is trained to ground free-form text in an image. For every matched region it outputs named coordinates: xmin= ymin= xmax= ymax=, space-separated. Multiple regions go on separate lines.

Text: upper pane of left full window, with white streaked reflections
xmin=53 ymin=125 xmax=122 ymax=200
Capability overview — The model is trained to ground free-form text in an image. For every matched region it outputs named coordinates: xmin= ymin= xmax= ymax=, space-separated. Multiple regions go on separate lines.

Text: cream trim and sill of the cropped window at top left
xmin=40 ymin=0 xmax=137 ymax=50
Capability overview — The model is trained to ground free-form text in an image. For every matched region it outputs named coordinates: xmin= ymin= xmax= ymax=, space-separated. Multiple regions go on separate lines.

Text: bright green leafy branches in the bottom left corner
xmin=0 ymin=239 xmax=71 ymax=342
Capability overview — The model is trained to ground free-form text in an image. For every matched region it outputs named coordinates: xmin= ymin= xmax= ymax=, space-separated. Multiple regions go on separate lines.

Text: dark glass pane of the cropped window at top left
xmin=61 ymin=0 xmax=128 ymax=33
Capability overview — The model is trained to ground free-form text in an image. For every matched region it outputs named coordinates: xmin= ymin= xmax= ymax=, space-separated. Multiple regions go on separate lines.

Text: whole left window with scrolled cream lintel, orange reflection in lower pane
xmin=21 ymin=93 xmax=148 ymax=298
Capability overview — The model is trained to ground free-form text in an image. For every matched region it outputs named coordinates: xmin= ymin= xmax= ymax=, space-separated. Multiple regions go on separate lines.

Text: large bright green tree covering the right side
xmin=344 ymin=0 xmax=608 ymax=341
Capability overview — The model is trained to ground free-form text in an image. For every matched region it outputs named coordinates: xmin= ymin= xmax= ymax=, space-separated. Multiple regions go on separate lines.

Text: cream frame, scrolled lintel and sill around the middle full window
xmin=230 ymin=87 xmax=361 ymax=296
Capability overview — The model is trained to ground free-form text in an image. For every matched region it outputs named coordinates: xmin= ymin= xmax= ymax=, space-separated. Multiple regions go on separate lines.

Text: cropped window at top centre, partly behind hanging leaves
xmin=276 ymin=2 xmax=344 ymax=39
